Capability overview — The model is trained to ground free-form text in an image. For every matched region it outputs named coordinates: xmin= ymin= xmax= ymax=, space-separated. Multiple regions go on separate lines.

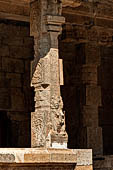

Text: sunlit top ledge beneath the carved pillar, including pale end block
xmin=0 ymin=148 xmax=93 ymax=166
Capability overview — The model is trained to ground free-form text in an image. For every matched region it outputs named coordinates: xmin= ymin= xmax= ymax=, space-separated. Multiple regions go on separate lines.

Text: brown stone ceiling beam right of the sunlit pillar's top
xmin=62 ymin=0 xmax=113 ymax=19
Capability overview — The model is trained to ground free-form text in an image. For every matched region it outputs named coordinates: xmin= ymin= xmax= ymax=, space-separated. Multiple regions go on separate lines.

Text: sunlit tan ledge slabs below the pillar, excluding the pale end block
xmin=0 ymin=148 xmax=77 ymax=164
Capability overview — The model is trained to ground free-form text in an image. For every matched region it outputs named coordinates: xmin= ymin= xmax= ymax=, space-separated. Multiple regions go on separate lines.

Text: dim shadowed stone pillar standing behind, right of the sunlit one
xmin=82 ymin=42 xmax=103 ymax=155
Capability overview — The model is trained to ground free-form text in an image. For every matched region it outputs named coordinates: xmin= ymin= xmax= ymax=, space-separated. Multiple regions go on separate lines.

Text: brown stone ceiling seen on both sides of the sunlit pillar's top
xmin=0 ymin=0 xmax=113 ymax=22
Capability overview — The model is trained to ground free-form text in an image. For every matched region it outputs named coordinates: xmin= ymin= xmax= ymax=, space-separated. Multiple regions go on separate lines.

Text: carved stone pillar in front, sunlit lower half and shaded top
xmin=30 ymin=0 xmax=67 ymax=148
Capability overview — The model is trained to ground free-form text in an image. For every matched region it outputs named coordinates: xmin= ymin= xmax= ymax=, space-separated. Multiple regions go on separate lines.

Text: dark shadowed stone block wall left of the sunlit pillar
xmin=0 ymin=20 xmax=34 ymax=147
